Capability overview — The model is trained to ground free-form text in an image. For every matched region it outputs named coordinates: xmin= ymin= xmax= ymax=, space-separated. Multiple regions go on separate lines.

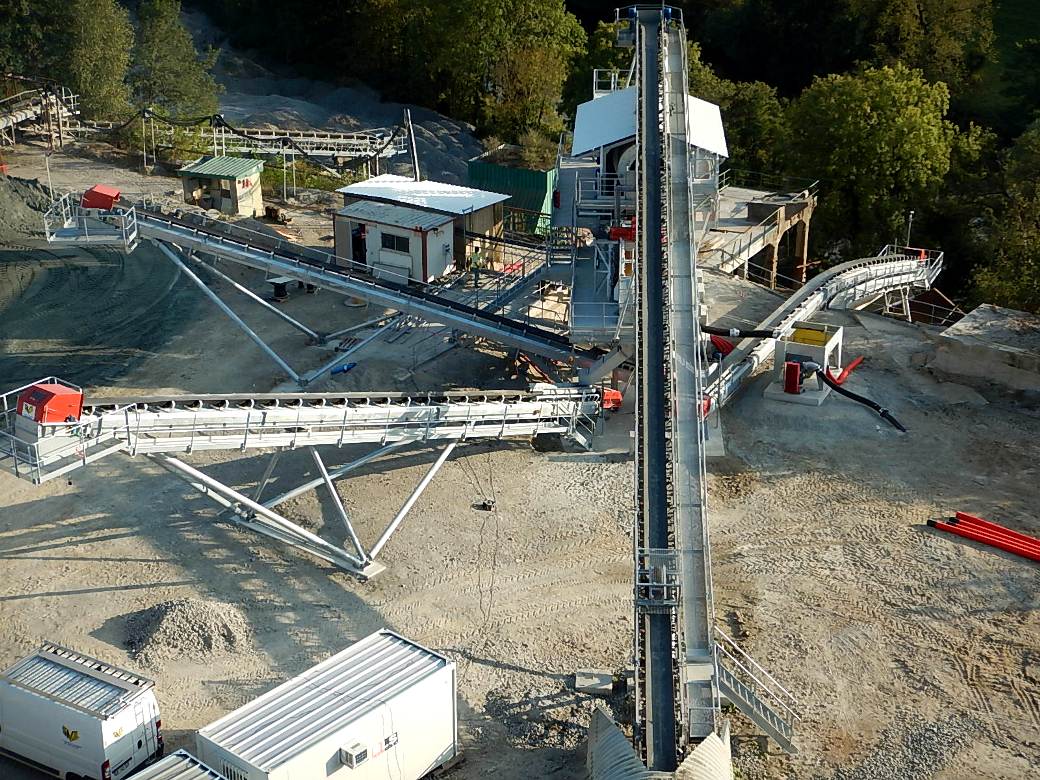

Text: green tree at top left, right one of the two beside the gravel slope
xmin=131 ymin=0 xmax=219 ymax=116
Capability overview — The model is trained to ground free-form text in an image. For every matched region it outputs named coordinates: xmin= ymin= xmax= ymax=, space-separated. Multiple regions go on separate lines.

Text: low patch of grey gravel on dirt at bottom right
xmin=833 ymin=716 xmax=979 ymax=780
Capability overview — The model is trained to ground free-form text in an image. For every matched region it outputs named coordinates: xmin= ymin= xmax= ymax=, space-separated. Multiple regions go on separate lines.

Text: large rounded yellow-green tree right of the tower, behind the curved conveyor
xmin=787 ymin=64 xmax=956 ymax=252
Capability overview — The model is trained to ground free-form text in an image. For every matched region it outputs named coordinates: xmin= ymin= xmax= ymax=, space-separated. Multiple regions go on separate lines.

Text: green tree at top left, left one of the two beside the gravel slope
xmin=56 ymin=0 xmax=133 ymax=120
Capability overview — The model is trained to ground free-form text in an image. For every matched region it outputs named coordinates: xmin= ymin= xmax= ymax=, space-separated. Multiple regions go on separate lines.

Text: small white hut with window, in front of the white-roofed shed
xmin=335 ymin=201 xmax=454 ymax=282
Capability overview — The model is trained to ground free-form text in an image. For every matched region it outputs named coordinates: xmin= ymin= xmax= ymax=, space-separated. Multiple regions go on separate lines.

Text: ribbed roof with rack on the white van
xmin=0 ymin=645 xmax=154 ymax=718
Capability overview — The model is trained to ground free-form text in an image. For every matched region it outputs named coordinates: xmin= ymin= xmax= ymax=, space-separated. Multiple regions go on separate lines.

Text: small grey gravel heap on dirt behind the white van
xmin=127 ymin=599 xmax=253 ymax=666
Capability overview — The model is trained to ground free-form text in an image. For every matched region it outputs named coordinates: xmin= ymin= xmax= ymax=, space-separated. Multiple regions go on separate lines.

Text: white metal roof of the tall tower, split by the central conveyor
xmin=571 ymin=86 xmax=729 ymax=157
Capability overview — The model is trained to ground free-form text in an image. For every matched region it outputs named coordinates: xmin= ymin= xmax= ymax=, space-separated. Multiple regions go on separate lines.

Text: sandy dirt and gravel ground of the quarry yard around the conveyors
xmin=0 ymin=147 xmax=1040 ymax=780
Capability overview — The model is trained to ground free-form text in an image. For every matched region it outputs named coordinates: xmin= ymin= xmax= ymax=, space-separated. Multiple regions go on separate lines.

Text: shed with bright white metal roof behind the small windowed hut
xmin=335 ymin=174 xmax=510 ymax=279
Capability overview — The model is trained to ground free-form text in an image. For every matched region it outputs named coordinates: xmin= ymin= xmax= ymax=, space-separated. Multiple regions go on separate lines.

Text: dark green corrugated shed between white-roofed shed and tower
xmin=466 ymin=144 xmax=556 ymax=235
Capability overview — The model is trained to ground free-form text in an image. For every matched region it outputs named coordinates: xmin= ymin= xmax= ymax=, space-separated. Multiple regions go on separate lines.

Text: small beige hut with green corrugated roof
xmin=177 ymin=156 xmax=263 ymax=217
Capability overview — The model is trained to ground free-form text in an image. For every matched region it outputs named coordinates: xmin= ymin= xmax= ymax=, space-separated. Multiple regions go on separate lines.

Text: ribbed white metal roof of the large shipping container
xmin=199 ymin=628 xmax=451 ymax=772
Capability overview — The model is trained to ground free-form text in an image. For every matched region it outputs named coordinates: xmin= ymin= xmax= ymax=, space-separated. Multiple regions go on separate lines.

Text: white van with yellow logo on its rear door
xmin=0 ymin=643 xmax=162 ymax=780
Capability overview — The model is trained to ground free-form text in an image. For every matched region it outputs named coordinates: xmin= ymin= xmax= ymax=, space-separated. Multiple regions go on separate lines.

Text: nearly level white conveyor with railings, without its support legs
xmin=0 ymin=378 xmax=599 ymax=484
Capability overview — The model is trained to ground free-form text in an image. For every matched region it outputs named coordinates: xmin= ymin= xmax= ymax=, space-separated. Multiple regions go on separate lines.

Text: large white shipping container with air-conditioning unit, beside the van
xmin=197 ymin=629 xmax=459 ymax=780
